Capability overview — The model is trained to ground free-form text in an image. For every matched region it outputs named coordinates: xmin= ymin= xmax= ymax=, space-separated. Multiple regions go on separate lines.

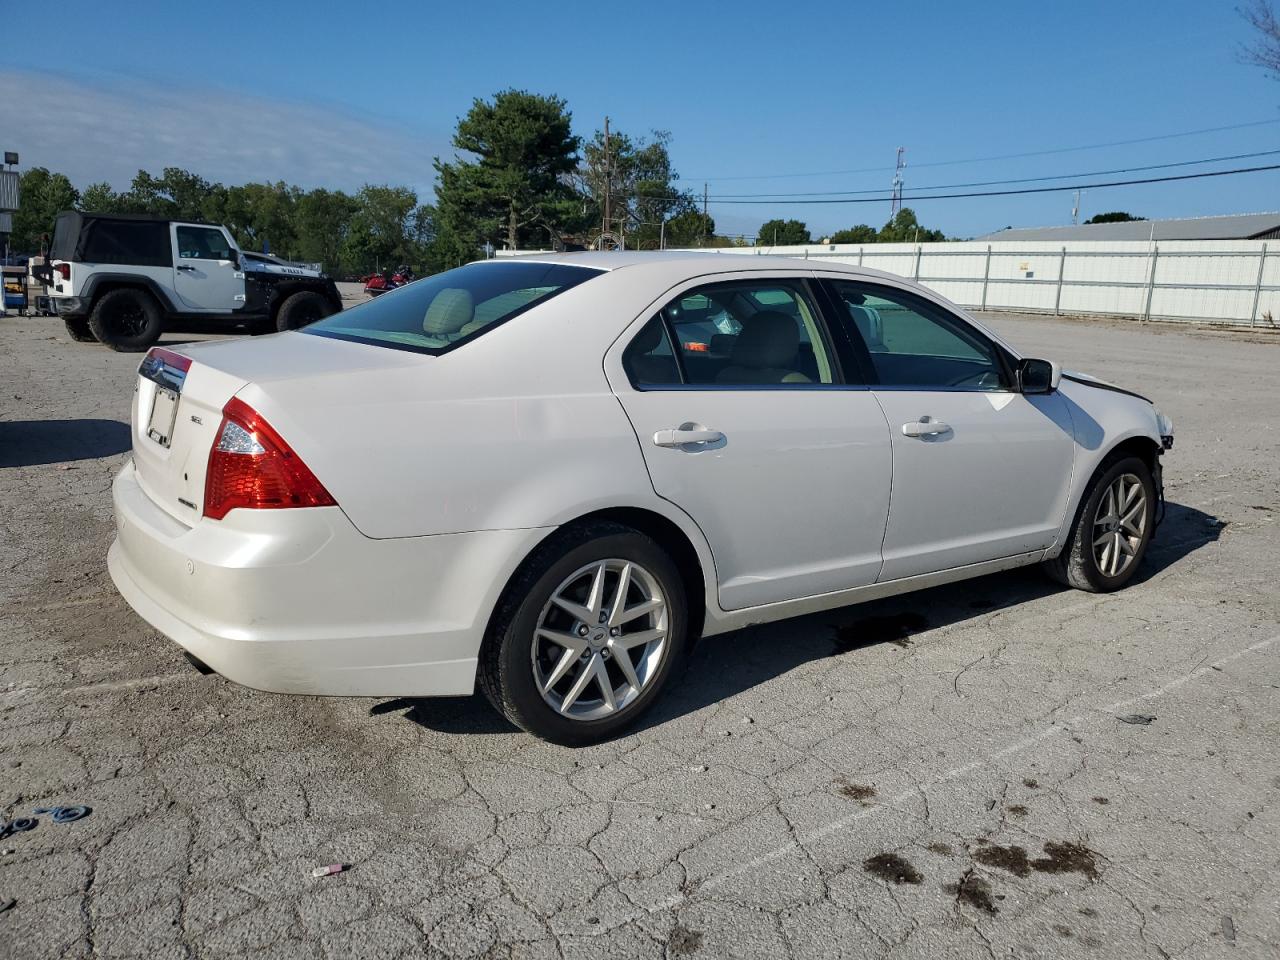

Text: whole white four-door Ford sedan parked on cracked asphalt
xmin=109 ymin=253 xmax=1172 ymax=744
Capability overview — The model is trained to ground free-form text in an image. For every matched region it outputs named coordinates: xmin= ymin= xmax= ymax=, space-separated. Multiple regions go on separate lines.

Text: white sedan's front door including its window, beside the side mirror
xmin=827 ymin=273 xmax=1075 ymax=580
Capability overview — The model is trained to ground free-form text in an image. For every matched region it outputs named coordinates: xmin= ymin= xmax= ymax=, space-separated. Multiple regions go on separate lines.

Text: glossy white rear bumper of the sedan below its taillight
xmin=108 ymin=461 xmax=545 ymax=696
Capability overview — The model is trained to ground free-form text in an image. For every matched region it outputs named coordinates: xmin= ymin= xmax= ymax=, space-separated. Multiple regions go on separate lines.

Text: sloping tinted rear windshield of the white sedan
xmin=302 ymin=260 xmax=600 ymax=353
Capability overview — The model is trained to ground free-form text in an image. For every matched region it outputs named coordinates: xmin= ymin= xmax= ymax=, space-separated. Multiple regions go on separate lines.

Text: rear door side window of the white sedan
xmin=623 ymin=279 xmax=836 ymax=387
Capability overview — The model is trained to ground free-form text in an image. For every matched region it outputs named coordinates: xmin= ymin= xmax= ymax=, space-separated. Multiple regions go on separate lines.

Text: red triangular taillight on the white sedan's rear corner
xmin=205 ymin=397 xmax=338 ymax=520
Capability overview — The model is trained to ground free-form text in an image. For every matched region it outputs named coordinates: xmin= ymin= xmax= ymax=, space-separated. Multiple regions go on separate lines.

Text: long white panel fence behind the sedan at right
xmin=696 ymin=241 xmax=1280 ymax=328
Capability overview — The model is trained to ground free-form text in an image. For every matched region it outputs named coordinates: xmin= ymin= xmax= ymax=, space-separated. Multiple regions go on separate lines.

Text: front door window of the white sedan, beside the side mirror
xmin=831 ymin=280 xmax=1007 ymax=390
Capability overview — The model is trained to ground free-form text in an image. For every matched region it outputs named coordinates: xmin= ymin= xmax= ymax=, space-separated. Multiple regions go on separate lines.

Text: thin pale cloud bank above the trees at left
xmin=0 ymin=70 xmax=453 ymax=198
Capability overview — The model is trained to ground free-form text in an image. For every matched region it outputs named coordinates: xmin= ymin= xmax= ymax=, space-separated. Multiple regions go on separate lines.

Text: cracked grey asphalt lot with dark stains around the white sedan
xmin=0 ymin=315 xmax=1280 ymax=960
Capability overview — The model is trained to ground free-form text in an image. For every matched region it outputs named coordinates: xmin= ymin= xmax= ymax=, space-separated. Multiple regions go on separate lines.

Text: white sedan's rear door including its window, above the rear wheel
xmin=607 ymin=274 xmax=890 ymax=609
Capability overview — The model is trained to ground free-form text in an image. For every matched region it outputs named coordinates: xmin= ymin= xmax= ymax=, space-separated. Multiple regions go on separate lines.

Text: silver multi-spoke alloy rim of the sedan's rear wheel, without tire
xmin=532 ymin=558 xmax=669 ymax=721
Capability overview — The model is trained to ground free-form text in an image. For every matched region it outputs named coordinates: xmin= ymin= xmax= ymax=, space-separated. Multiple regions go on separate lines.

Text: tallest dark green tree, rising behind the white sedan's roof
xmin=435 ymin=90 xmax=580 ymax=248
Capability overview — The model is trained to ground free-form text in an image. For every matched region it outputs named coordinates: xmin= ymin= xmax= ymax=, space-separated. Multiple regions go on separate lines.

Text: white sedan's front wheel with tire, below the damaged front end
xmin=1044 ymin=457 xmax=1156 ymax=593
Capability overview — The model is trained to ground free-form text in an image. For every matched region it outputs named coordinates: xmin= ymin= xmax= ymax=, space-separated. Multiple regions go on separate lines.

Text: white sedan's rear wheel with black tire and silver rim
xmin=480 ymin=522 xmax=689 ymax=746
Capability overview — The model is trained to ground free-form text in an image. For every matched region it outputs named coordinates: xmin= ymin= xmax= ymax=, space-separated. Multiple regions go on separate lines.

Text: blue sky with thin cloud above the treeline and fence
xmin=0 ymin=0 xmax=1280 ymax=236
